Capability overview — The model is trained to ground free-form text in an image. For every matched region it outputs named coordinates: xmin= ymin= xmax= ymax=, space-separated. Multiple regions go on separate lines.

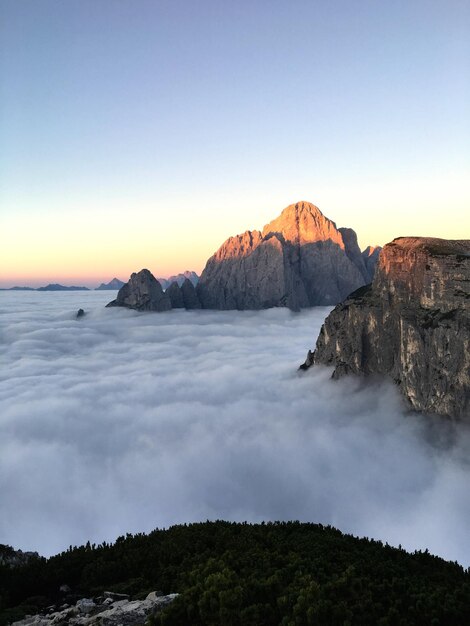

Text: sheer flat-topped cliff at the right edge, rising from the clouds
xmin=304 ymin=237 xmax=470 ymax=418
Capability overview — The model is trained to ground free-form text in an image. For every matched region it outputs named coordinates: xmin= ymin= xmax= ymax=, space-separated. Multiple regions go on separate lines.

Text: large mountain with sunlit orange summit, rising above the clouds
xmin=197 ymin=202 xmax=376 ymax=310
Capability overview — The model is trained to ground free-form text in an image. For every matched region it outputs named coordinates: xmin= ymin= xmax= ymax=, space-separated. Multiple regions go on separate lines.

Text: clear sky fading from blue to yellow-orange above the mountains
xmin=0 ymin=0 xmax=470 ymax=286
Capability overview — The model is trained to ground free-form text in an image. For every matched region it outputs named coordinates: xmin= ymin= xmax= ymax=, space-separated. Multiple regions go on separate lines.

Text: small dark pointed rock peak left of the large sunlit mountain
xmin=106 ymin=269 xmax=171 ymax=311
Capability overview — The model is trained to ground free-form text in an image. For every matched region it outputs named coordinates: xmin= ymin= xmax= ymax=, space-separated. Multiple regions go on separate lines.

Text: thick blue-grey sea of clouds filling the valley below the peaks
xmin=0 ymin=292 xmax=470 ymax=565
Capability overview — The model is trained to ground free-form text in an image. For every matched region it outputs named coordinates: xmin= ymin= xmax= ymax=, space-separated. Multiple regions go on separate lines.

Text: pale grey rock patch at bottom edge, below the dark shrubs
xmin=12 ymin=591 xmax=178 ymax=626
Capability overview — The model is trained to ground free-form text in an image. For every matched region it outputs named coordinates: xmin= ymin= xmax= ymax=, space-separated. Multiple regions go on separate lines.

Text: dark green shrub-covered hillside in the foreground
xmin=0 ymin=521 xmax=470 ymax=626
